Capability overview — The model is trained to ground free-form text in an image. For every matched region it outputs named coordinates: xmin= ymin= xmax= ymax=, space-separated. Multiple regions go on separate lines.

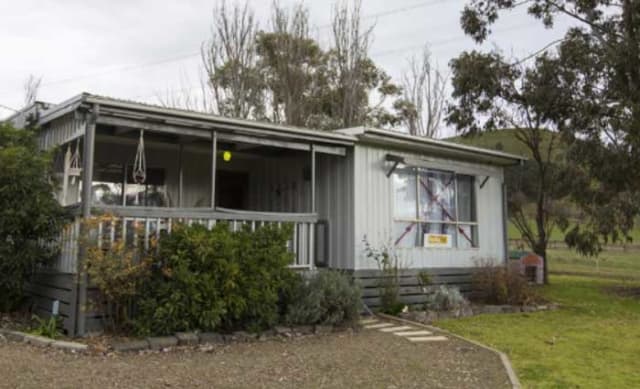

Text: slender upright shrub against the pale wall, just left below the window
xmin=363 ymin=237 xmax=405 ymax=315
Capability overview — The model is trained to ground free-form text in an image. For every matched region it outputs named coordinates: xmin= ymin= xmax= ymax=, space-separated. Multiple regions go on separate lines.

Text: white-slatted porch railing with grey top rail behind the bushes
xmin=56 ymin=206 xmax=318 ymax=272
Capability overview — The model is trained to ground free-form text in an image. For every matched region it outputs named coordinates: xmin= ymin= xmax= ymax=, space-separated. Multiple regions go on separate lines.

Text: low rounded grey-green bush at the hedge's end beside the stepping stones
xmin=285 ymin=270 xmax=362 ymax=325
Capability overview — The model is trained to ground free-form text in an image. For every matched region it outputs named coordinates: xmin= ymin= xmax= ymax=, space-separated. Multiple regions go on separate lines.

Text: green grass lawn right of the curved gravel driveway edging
xmin=436 ymin=274 xmax=640 ymax=388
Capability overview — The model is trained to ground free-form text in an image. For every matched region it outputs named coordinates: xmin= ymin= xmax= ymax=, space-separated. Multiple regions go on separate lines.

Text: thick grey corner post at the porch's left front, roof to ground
xmin=75 ymin=104 xmax=100 ymax=336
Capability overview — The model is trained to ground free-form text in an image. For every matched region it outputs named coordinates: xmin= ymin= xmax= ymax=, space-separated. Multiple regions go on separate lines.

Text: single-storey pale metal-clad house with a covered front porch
xmin=6 ymin=93 xmax=522 ymax=335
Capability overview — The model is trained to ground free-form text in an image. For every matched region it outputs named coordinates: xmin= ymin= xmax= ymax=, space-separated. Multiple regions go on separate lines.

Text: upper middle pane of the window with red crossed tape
xmin=419 ymin=171 xmax=456 ymax=221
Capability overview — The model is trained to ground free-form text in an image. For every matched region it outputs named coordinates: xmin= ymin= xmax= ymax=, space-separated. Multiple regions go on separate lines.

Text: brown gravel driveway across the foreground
xmin=0 ymin=331 xmax=509 ymax=388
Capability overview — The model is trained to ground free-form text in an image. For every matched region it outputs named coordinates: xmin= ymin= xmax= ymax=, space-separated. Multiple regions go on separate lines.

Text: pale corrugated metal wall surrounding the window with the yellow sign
xmin=354 ymin=145 xmax=504 ymax=269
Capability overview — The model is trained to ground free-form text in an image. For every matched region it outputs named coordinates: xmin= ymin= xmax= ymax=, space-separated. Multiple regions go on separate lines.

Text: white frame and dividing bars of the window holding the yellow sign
xmin=391 ymin=165 xmax=480 ymax=250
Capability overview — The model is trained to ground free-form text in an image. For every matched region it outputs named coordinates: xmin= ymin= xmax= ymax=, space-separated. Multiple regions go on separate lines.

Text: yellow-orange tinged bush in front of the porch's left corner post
xmin=81 ymin=215 xmax=155 ymax=331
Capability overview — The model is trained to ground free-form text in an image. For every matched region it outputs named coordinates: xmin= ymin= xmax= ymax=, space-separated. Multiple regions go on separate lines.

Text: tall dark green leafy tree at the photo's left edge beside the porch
xmin=0 ymin=124 xmax=66 ymax=312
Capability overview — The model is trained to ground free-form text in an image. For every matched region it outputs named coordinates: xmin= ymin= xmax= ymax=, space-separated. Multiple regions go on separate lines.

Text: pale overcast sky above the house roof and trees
xmin=0 ymin=0 xmax=568 ymax=135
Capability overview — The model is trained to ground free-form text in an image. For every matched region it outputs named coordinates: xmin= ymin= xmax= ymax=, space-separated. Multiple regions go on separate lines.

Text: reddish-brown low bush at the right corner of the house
xmin=471 ymin=261 xmax=541 ymax=305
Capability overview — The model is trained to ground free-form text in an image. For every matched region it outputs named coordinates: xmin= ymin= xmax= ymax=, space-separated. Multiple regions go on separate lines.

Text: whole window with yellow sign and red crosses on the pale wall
xmin=393 ymin=167 xmax=478 ymax=249
